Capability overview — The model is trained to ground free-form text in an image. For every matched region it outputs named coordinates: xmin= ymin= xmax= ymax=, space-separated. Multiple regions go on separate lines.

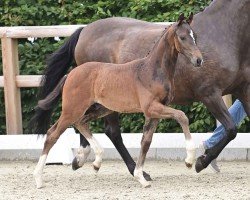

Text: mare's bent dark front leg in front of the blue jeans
xmin=195 ymin=95 xmax=237 ymax=173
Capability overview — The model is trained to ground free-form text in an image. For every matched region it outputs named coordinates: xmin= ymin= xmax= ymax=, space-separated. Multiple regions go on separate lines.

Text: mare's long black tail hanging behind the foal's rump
xmin=27 ymin=28 xmax=83 ymax=135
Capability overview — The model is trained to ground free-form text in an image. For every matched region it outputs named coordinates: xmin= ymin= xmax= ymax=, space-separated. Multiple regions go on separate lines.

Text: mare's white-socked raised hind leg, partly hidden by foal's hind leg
xmin=72 ymin=104 xmax=113 ymax=170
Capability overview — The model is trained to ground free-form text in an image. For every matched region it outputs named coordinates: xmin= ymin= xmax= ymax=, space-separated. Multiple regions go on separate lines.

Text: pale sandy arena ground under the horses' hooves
xmin=0 ymin=160 xmax=250 ymax=200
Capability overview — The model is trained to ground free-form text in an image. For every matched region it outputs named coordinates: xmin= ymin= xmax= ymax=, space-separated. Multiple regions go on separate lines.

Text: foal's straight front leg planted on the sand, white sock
xmin=134 ymin=118 xmax=158 ymax=187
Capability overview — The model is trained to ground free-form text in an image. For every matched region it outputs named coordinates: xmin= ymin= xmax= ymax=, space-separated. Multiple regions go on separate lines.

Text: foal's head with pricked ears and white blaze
xmin=168 ymin=13 xmax=203 ymax=67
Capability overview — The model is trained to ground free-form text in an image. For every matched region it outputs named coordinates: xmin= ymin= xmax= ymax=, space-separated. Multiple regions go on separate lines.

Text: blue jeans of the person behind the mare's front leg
xmin=203 ymin=99 xmax=247 ymax=149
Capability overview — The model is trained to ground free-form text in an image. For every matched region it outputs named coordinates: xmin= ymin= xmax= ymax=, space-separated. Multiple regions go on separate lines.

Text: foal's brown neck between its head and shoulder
xmin=147 ymin=31 xmax=178 ymax=78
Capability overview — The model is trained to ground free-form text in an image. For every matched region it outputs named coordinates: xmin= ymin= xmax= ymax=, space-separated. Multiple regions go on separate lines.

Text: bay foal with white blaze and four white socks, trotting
xmin=34 ymin=14 xmax=202 ymax=188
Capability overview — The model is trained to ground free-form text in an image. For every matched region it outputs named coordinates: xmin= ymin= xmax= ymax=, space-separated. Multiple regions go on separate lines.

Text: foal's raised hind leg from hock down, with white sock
xmin=75 ymin=123 xmax=104 ymax=172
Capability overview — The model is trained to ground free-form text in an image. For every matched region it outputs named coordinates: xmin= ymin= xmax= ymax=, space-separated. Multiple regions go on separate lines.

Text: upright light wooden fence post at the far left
xmin=1 ymin=36 xmax=23 ymax=134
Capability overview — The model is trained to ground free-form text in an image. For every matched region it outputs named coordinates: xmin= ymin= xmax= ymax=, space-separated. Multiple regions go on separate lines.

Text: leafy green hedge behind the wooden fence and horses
xmin=0 ymin=0 xmax=250 ymax=134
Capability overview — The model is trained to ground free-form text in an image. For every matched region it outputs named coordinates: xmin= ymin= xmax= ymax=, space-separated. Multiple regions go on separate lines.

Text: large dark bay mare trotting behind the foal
xmin=29 ymin=0 xmax=250 ymax=179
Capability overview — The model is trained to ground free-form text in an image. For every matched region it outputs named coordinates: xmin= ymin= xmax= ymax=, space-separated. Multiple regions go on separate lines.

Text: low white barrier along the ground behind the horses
xmin=0 ymin=128 xmax=250 ymax=164
